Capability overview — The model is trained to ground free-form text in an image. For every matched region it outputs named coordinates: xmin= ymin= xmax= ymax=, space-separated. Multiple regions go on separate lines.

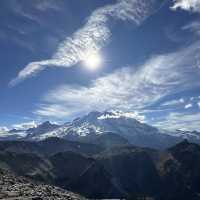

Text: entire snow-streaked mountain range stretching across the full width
xmin=0 ymin=111 xmax=200 ymax=148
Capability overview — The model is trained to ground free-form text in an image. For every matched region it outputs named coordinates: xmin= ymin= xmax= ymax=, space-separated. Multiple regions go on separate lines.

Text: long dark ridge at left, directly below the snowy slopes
xmin=0 ymin=138 xmax=103 ymax=156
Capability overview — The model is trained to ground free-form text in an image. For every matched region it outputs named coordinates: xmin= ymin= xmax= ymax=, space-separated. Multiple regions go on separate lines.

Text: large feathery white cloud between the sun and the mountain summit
xmin=35 ymin=42 xmax=200 ymax=118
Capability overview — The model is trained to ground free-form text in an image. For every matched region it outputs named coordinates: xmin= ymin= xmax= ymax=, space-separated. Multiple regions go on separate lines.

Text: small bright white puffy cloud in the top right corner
xmin=171 ymin=0 xmax=200 ymax=12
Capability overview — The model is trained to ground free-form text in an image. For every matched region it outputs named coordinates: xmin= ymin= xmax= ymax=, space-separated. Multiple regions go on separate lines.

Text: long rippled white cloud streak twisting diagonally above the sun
xmin=10 ymin=0 xmax=159 ymax=86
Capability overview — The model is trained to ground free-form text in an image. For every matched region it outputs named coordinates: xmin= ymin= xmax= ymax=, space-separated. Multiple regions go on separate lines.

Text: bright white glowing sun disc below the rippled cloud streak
xmin=83 ymin=52 xmax=102 ymax=70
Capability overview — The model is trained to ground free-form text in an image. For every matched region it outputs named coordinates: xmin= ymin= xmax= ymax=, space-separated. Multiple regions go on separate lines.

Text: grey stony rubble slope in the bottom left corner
xmin=0 ymin=171 xmax=85 ymax=200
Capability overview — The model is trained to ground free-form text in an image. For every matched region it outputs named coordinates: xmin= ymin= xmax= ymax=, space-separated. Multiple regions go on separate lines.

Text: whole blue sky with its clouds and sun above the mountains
xmin=0 ymin=0 xmax=200 ymax=131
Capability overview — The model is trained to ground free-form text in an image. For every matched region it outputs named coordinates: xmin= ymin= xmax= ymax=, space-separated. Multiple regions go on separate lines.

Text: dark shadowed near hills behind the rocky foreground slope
xmin=0 ymin=138 xmax=200 ymax=200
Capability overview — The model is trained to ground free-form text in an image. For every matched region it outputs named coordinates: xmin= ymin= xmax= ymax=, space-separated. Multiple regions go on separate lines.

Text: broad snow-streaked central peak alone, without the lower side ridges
xmin=30 ymin=111 xmax=158 ymax=139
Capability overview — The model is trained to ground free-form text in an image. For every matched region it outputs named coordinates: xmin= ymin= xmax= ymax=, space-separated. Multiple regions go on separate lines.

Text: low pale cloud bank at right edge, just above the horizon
xmin=154 ymin=112 xmax=200 ymax=131
